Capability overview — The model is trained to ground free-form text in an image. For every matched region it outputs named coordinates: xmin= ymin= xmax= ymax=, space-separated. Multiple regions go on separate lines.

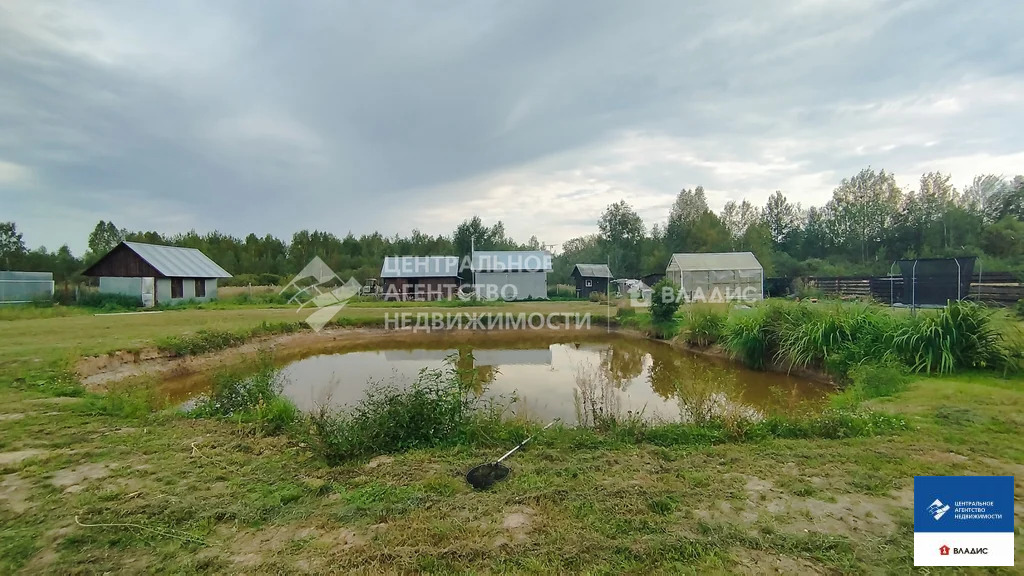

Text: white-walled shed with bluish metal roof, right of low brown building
xmin=470 ymin=250 xmax=551 ymax=300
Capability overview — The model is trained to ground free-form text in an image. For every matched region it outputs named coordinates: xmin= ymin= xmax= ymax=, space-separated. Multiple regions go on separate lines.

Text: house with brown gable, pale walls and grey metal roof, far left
xmin=82 ymin=242 xmax=231 ymax=306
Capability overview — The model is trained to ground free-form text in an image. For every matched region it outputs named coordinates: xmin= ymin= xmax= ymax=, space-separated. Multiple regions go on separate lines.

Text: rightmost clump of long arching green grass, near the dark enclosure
xmin=893 ymin=302 xmax=1013 ymax=374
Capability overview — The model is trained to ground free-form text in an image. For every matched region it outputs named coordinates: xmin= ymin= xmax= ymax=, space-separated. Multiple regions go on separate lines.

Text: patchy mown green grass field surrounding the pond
xmin=0 ymin=302 xmax=1024 ymax=574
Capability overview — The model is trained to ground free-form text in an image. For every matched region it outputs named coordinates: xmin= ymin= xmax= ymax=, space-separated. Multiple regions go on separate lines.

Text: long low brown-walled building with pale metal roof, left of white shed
xmin=381 ymin=256 xmax=460 ymax=300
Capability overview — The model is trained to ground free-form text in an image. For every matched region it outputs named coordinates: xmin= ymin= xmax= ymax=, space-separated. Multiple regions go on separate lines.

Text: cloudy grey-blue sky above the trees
xmin=0 ymin=0 xmax=1024 ymax=254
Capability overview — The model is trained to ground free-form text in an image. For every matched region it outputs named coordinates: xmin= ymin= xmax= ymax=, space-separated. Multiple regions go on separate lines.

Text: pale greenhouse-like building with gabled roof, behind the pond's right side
xmin=665 ymin=252 xmax=765 ymax=302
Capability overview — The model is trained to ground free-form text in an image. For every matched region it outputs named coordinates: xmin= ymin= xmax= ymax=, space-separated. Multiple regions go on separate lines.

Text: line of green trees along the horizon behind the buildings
xmin=0 ymin=168 xmax=1024 ymax=284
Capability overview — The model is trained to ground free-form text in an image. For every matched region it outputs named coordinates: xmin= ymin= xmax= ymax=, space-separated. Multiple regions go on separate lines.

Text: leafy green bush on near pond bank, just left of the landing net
xmin=310 ymin=364 xmax=512 ymax=464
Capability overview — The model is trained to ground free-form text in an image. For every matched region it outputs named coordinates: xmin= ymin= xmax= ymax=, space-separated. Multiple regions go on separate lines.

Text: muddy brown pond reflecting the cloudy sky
xmin=161 ymin=333 xmax=833 ymax=423
